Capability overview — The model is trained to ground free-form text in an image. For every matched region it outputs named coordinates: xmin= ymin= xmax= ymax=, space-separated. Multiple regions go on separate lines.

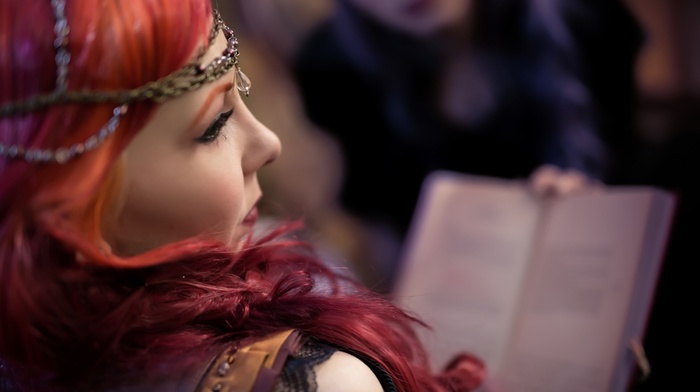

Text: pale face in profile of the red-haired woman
xmin=105 ymin=33 xmax=280 ymax=256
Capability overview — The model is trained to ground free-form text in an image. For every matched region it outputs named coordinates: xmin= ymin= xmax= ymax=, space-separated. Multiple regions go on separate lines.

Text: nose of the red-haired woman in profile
xmin=243 ymin=114 xmax=282 ymax=174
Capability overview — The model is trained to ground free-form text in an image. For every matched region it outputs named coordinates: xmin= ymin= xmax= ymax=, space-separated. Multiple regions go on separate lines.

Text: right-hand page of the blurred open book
xmin=500 ymin=189 xmax=668 ymax=392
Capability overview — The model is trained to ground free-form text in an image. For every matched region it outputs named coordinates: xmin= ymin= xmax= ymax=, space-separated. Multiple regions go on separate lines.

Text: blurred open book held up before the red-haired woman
xmin=394 ymin=172 xmax=676 ymax=392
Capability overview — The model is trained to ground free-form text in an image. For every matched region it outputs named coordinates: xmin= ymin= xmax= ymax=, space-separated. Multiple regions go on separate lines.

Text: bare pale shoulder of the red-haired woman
xmin=314 ymin=351 xmax=383 ymax=392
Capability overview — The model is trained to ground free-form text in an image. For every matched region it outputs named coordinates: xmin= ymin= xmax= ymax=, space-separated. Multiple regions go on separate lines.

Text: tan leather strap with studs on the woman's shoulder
xmin=196 ymin=329 xmax=300 ymax=392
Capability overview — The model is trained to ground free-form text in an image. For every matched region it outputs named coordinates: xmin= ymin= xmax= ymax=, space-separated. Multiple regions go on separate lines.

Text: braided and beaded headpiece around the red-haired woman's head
xmin=0 ymin=0 xmax=250 ymax=163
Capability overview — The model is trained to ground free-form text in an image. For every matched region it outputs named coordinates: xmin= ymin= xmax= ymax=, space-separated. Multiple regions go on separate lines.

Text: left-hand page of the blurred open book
xmin=394 ymin=173 xmax=539 ymax=372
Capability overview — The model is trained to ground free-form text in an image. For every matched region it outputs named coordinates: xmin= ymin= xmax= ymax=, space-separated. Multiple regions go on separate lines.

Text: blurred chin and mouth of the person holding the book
xmin=349 ymin=0 xmax=471 ymax=36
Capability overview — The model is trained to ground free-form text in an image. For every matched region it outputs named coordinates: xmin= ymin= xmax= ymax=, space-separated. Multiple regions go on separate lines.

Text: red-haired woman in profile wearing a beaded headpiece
xmin=0 ymin=0 xmax=482 ymax=391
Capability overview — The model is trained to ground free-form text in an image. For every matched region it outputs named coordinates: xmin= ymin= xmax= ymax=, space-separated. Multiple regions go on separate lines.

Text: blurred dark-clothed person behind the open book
xmin=291 ymin=0 xmax=642 ymax=291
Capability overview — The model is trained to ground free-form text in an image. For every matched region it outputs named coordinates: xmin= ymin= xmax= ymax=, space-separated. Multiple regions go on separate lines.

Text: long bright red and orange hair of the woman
xmin=0 ymin=0 xmax=476 ymax=391
